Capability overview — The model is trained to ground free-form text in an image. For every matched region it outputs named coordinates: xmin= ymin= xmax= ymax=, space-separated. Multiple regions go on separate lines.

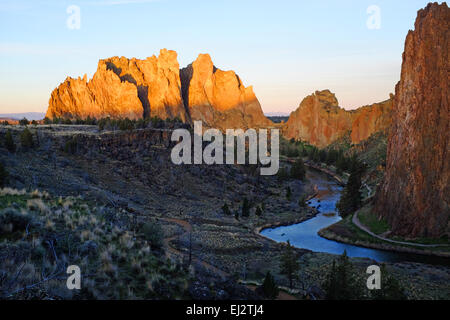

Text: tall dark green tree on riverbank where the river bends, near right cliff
xmin=336 ymin=162 xmax=364 ymax=217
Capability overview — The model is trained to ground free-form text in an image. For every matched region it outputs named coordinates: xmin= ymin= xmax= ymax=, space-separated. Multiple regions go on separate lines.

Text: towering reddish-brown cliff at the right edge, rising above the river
xmin=375 ymin=3 xmax=450 ymax=237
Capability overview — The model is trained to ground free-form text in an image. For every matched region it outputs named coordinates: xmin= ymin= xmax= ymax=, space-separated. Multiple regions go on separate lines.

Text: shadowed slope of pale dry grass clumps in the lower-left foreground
xmin=0 ymin=188 xmax=189 ymax=299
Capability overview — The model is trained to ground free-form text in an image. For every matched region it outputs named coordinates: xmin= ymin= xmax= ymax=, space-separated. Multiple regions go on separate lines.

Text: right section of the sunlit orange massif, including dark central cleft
xmin=180 ymin=54 xmax=271 ymax=129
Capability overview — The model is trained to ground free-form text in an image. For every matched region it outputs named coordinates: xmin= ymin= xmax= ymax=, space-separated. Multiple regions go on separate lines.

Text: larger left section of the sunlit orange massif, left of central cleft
xmin=47 ymin=49 xmax=187 ymax=121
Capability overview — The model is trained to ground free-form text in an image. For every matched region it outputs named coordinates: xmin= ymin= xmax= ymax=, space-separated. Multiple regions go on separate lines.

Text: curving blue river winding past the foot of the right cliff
xmin=261 ymin=169 xmax=450 ymax=265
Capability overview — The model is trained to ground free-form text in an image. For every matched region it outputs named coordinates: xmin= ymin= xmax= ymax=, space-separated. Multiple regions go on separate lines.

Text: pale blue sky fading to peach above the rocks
xmin=0 ymin=0 xmax=436 ymax=113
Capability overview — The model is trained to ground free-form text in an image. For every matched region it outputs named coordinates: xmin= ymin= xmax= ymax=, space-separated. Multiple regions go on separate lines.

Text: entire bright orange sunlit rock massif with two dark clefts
xmin=46 ymin=49 xmax=271 ymax=129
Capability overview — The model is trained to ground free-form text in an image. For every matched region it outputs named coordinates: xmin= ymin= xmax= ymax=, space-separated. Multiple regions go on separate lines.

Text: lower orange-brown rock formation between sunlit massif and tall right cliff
xmin=283 ymin=90 xmax=392 ymax=148
